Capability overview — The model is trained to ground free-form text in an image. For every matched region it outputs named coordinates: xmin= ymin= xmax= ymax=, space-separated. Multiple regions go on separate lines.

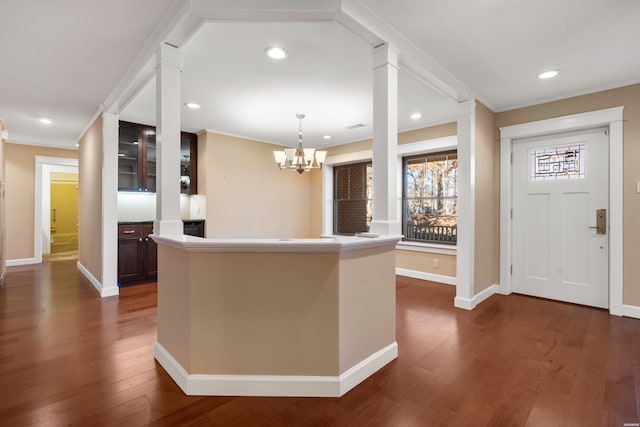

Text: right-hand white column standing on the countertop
xmin=371 ymin=44 xmax=401 ymax=235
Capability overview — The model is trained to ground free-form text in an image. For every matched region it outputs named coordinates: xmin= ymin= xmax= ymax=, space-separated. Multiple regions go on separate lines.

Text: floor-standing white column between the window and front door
xmin=454 ymin=98 xmax=476 ymax=310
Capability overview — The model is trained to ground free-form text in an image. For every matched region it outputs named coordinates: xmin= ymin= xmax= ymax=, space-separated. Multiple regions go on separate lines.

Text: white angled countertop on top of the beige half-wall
xmin=150 ymin=235 xmax=402 ymax=252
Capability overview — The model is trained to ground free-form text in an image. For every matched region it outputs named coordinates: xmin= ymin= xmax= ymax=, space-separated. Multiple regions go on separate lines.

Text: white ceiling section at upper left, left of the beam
xmin=0 ymin=0 xmax=174 ymax=148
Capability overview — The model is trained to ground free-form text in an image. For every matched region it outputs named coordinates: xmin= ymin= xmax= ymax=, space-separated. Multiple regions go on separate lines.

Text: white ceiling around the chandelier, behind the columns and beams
xmin=121 ymin=23 xmax=456 ymax=147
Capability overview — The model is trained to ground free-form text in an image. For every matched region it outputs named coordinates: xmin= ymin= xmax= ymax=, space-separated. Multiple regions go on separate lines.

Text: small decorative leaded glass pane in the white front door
xmin=529 ymin=144 xmax=585 ymax=181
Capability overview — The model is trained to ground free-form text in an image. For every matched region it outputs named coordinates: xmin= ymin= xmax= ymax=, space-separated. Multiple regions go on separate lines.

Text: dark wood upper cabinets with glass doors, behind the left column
xmin=118 ymin=121 xmax=198 ymax=194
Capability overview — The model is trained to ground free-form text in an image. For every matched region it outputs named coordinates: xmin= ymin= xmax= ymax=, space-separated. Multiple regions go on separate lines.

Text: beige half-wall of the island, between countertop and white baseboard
xmin=158 ymin=243 xmax=395 ymax=376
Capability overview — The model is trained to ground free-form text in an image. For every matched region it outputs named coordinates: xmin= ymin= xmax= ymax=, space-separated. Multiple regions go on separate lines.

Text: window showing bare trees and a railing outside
xmin=402 ymin=151 xmax=458 ymax=244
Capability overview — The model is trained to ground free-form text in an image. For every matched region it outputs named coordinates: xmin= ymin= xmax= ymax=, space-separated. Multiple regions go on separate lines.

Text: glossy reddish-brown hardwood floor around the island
xmin=0 ymin=261 xmax=640 ymax=427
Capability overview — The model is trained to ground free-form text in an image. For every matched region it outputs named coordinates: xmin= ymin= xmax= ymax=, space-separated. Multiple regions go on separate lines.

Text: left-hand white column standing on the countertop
xmin=153 ymin=43 xmax=183 ymax=238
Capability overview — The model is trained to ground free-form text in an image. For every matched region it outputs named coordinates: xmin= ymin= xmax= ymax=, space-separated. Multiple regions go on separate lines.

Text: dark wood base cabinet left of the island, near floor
xmin=118 ymin=223 xmax=158 ymax=286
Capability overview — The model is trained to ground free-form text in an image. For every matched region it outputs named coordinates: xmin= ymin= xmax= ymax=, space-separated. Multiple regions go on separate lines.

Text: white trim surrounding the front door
xmin=499 ymin=107 xmax=624 ymax=316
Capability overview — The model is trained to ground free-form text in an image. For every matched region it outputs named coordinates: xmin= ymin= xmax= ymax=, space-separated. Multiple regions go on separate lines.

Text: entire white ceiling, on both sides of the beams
xmin=0 ymin=0 xmax=640 ymax=147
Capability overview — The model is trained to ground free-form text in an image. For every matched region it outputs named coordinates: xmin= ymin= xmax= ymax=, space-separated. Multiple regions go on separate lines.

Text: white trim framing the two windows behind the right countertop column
xmin=322 ymin=135 xmax=458 ymax=255
